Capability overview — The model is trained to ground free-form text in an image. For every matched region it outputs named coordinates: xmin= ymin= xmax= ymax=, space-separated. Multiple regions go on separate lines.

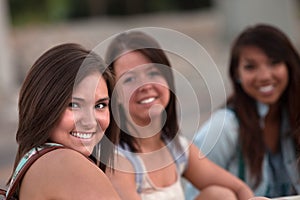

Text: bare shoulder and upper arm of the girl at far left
xmin=20 ymin=149 xmax=120 ymax=200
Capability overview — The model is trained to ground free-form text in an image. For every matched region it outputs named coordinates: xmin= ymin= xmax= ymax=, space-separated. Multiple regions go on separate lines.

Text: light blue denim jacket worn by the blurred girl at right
xmin=185 ymin=104 xmax=300 ymax=200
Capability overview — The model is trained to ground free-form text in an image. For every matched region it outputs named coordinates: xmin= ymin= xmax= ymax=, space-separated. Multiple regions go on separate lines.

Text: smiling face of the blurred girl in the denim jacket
xmin=237 ymin=46 xmax=289 ymax=104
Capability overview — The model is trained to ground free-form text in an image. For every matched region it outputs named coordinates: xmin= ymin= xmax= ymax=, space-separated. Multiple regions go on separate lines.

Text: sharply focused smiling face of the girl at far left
xmin=50 ymin=73 xmax=110 ymax=156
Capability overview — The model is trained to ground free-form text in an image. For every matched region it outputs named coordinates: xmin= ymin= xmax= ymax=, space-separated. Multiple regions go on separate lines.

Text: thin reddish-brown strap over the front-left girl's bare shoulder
xmin=5 ymin=146 xmax=65 ymax=200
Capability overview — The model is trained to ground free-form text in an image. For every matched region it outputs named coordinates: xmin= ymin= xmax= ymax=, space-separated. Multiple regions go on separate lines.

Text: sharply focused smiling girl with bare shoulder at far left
xmin=8 ymin=43 xmax=119 ymax=200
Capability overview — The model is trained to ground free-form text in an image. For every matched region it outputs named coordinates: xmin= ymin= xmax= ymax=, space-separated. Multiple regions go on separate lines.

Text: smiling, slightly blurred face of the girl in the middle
xmin=114 ymin=51 xmax=170 ymax=126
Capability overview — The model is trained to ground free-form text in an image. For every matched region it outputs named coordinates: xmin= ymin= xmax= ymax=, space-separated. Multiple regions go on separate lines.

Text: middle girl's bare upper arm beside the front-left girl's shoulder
xmin=105 ymin=155 xmax=141 ymax=200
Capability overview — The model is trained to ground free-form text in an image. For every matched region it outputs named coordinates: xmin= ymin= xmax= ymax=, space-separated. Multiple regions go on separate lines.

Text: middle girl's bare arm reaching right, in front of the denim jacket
xmin=184 ymin=144 xmax=253 ymax=200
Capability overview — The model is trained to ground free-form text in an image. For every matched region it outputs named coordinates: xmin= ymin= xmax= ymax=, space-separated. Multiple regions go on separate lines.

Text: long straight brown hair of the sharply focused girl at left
xmin=9 ymin=43 xmax=117 ymax=184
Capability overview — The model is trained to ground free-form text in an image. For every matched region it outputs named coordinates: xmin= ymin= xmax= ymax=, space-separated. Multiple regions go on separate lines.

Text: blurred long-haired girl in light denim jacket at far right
xmin=186 ymin=24 xmax=300 ymax=198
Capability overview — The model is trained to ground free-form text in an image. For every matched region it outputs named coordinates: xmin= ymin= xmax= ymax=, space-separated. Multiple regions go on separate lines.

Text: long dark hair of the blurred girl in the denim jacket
xmin=228 ymin=24 xmax=300 ymax=184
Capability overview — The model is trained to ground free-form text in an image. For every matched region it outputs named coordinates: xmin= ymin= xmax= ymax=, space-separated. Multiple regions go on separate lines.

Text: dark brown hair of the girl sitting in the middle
xmin=106 ymin=31 xmax=179 ymax=152
